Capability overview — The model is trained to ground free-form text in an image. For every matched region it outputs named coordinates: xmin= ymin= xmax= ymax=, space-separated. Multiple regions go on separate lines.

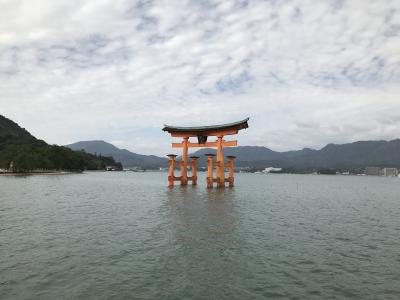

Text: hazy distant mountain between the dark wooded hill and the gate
xmin=66 ymin=141 xmax=168 ymax=169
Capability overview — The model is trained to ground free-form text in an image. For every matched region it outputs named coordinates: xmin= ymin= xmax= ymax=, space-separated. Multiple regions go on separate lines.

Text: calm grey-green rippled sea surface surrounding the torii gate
xmin=0 ymin=172 xmax=400 ymax=299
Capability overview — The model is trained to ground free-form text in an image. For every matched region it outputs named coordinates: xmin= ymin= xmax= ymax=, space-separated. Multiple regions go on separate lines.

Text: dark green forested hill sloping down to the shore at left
xmin=0 ymin=115 xmax=122 ymax=172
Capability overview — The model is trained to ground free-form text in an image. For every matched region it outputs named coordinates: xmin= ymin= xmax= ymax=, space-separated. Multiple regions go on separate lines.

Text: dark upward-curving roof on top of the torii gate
xmin=162 ymin=118 xmax=250 ymax=136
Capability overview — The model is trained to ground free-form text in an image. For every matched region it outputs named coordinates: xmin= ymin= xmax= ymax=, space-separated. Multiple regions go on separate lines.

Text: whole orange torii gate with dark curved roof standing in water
xmin=162 ymin=118 xmax=249 ymax=187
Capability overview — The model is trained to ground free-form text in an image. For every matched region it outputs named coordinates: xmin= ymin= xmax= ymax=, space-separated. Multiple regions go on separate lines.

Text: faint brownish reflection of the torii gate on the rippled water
xmin=162 ymin=186 xmax=241 ymax=297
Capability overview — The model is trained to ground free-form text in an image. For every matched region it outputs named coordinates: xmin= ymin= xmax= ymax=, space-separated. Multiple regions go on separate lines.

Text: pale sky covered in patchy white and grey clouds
xmin=0 ymin=0 xmax=400 ymax=155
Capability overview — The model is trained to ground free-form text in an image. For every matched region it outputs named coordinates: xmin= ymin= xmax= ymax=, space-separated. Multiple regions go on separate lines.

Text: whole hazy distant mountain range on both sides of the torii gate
xmin=67 ymin=139 xmax=400 ymax=172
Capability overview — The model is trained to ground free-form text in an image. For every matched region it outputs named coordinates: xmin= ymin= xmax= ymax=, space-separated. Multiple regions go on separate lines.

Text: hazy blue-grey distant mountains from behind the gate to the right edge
xmin=191 ymin=139 xmax=400 ymax=171
